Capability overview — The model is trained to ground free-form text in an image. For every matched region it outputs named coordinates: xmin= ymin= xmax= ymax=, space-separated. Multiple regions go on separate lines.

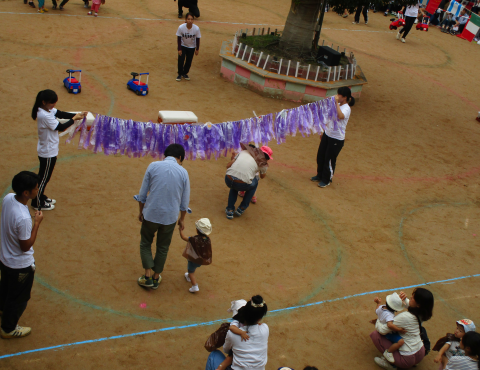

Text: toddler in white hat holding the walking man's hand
xmin=178 ymin=218 xmax=212 ymax=293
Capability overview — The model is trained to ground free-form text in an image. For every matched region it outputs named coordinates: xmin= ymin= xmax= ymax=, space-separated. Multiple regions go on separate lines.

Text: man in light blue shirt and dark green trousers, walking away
xmin=134 ymin=144 xmax=190 ymax=289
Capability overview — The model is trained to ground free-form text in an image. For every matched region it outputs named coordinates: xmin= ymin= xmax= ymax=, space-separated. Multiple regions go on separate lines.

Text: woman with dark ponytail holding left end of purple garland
xmin=32 ymin=90 xmax=87 ymax=211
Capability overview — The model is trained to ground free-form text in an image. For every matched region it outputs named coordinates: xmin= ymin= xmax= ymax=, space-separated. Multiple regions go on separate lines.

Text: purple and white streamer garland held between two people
xmin=66 ymin=97 xmax=338 ymax=160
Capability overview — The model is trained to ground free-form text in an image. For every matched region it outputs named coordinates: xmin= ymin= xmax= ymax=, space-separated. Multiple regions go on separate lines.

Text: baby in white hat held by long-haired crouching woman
xmin=373 ymin=293 xmax=406 ymax=363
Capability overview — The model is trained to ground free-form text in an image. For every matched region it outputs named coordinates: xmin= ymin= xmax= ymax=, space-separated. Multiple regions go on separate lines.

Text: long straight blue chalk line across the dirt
xmin=0 ymin=274 xmax=480 ymax=359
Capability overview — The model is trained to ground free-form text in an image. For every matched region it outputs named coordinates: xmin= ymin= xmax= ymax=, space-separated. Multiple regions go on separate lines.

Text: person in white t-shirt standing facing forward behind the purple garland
xmin=177 ymin=13 xmax=202 ymax=82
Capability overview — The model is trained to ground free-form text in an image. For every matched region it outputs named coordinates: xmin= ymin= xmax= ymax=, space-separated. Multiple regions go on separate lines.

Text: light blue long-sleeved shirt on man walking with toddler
xmin=134 ymin=157 xmax=190 ymax=225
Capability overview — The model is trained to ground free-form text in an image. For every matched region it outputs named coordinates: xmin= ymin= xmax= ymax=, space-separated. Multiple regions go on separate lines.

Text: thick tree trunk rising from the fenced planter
xmin=280 ymin=0 xmax=322 ymax=55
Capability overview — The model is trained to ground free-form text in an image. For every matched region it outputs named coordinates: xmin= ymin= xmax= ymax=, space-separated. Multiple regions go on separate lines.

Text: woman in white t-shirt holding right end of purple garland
xmin=310 ymin=86 xmax=355 ymax=188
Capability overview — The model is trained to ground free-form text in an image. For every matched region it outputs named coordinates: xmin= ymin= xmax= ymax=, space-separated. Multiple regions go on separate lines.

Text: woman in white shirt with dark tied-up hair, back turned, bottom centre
xmin=207 ymin=295 xmax=269 ymax=370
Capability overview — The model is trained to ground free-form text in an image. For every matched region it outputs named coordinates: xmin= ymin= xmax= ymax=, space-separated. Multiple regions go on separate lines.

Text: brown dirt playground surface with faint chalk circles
xmin=0 ymin=0 xmax=480 ymax=370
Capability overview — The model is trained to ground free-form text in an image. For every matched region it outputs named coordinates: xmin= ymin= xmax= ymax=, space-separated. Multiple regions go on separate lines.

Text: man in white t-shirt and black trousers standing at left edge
xmin=0 ymin=171 xmax=43 ymax=339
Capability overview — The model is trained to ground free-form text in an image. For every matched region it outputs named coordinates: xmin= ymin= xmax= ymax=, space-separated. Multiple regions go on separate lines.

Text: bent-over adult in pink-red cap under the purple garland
xmin=225 ymin=144 xmax=273 ymax=220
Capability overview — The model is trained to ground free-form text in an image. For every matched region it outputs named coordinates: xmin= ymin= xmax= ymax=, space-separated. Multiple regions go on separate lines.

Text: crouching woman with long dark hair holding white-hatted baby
xmin=370 ymin=288 xmax=434 ymax=370
